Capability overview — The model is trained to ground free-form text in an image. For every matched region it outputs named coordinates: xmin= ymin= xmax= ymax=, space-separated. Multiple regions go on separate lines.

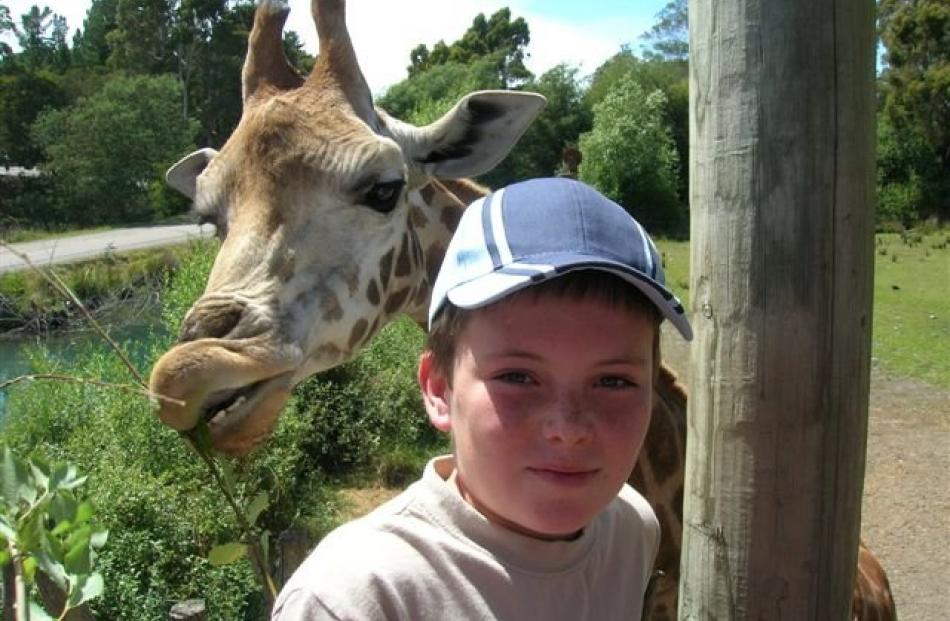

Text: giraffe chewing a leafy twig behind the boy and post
xmin=150 ymin=0 xmax=895 ymax=621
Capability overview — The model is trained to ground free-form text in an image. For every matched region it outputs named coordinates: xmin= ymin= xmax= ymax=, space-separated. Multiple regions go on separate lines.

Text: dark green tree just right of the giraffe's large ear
xmin=480 ymin=64 xmax=592 ymax=187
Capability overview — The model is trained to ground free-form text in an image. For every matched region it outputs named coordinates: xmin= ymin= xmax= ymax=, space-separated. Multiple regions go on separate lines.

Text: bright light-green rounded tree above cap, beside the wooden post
xmin=580 ymin=76 xmax=687 ymax=234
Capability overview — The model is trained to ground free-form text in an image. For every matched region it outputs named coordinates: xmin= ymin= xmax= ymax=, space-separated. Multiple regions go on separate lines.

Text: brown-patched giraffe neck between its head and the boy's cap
xmin=403 ymin=179 xmax=488 ymax=327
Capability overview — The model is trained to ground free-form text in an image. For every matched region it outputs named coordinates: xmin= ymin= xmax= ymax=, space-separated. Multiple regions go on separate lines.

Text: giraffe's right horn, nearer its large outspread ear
xmin=310 ymin=0 xmax=373 ymax=119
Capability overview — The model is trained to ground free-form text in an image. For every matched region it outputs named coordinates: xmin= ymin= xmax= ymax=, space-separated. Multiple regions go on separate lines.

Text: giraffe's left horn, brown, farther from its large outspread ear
xmin=241 ymin=0 xmax=303 ymax=104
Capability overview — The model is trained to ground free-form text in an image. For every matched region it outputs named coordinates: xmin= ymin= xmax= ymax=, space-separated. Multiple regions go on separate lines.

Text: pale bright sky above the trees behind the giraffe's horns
xmin=4 ymin=0 xmax=668 ymax=93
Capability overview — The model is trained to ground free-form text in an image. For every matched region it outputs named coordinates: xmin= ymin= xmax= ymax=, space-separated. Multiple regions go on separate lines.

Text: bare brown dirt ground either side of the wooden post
xmin=663 ymin=326 xmax=950 ymax=621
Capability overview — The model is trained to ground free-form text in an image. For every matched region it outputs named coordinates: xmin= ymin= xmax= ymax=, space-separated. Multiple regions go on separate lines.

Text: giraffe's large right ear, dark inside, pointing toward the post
xmin=385 ymin=91 xmax=547 ymax=178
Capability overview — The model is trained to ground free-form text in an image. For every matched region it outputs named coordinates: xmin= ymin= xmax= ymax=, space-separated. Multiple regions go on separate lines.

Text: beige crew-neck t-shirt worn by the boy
xmin=271 ymin=456 xmax=660 ymax=621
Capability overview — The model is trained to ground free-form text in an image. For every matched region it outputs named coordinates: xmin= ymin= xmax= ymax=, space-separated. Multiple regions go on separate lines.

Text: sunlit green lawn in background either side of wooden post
xmin=657 ymin=230 xmax=950 ymax=388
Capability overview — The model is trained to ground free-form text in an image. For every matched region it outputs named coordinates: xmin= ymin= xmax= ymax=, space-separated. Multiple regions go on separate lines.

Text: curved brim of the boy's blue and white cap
xmin=446 ymin=254 xmax=693 ymax=341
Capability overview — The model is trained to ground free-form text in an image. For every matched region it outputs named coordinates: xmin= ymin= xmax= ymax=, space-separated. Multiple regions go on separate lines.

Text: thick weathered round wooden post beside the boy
xmin=680 ymin=0 xmax=875 ymax=621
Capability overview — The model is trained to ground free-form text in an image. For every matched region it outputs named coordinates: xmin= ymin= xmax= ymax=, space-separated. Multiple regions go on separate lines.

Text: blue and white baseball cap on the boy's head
xmin=429 ymin=178 xmax=693 ymax=340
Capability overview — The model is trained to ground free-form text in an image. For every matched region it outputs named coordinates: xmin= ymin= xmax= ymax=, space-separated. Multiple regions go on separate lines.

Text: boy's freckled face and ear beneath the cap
xmin=419 ymin=294 xmax=656 ymax=538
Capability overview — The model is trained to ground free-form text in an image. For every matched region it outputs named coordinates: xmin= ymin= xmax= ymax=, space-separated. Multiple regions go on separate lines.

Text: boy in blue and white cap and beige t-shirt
xmin=273 ymin=178 xmax=691 ymax=621
